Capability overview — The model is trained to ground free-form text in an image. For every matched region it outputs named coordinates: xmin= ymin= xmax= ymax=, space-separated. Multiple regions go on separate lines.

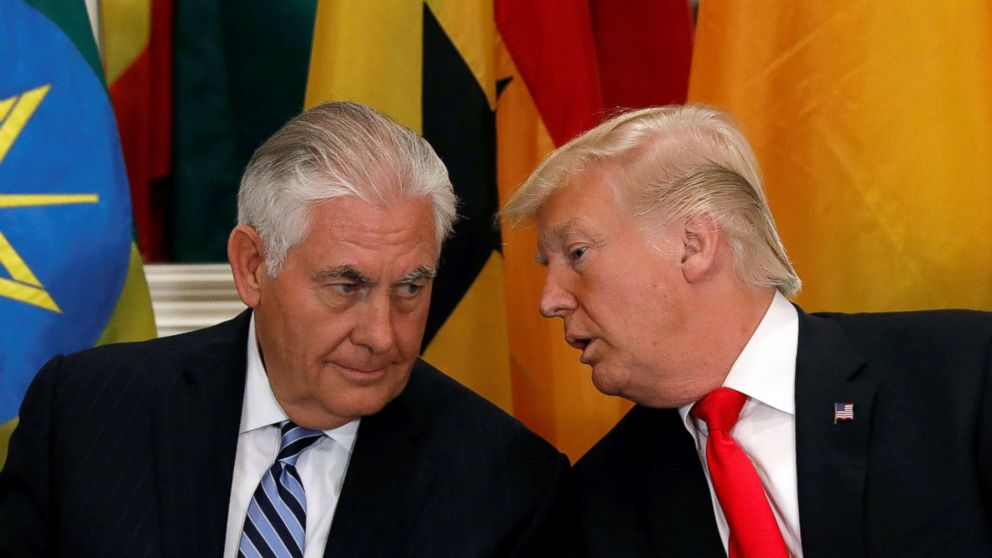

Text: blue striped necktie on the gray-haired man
xmin=238 ymin=420 xmax=324 ymax=558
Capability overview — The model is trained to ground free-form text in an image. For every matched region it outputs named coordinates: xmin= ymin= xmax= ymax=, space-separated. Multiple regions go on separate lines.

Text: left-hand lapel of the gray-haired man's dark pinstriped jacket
xmin=153 ymin=312 xmax=250 ymax=557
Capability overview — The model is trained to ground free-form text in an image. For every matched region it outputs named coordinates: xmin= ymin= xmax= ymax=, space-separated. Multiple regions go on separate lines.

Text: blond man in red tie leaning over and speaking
xmin=504 ymin=105 xmax=992 ymax=558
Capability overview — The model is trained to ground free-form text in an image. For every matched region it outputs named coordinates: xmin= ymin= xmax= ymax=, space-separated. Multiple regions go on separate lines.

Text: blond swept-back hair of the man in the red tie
xmin=502 ymin=105 xmax=802 ymax=296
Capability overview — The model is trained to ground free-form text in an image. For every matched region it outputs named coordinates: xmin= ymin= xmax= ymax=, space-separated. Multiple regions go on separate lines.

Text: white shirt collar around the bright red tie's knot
xmin=679 ymin=291 xmax=799 ymax=427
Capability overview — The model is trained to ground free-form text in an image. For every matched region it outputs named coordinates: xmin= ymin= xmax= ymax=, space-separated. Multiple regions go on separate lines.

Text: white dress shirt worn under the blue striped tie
xmin=224 ymin=315 xmax=359 ymax=558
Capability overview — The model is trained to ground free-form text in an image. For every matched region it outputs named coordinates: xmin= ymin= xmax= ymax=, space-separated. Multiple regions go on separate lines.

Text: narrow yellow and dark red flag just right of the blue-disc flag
xmin=100 ymin=0 xmax=173 ymax=261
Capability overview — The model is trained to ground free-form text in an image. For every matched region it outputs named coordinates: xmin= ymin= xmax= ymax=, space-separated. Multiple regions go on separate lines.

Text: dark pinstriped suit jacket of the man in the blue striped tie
xmin=0 ymin=312 xmax=568 ymax=558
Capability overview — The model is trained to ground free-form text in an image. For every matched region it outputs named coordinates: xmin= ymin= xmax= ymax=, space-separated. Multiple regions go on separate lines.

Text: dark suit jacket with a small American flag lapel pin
xmin=574 ymin=311 xmax=992 ymax=558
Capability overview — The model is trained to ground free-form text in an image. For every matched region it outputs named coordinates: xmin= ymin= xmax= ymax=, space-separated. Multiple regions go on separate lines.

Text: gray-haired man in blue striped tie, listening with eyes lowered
xmin=0 ymin=103 xmax=568 ymax=558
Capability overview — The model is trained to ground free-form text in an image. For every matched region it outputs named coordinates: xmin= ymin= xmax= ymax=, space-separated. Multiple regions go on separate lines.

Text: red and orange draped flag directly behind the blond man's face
xmin=496 ymin=0 xmax=692 ymax=460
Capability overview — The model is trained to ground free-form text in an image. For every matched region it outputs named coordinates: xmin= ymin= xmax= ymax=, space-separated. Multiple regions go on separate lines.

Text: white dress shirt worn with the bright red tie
xmin=679 ymin=291 xmax=803 ymax=558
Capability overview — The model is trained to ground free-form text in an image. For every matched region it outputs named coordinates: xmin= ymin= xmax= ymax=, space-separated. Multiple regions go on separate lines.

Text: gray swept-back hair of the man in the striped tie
xmin=238 ymin=102 xmax=457 ymax=277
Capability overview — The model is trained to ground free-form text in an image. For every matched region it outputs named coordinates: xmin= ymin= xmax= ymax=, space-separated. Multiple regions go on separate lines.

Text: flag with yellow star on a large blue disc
xmin=0 ymin=0 xmax=155 ymax=468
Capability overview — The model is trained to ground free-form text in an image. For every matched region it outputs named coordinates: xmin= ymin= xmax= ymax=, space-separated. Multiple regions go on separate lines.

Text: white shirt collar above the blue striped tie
xmin=240 ymin=313 xmax=361 ymax=448
